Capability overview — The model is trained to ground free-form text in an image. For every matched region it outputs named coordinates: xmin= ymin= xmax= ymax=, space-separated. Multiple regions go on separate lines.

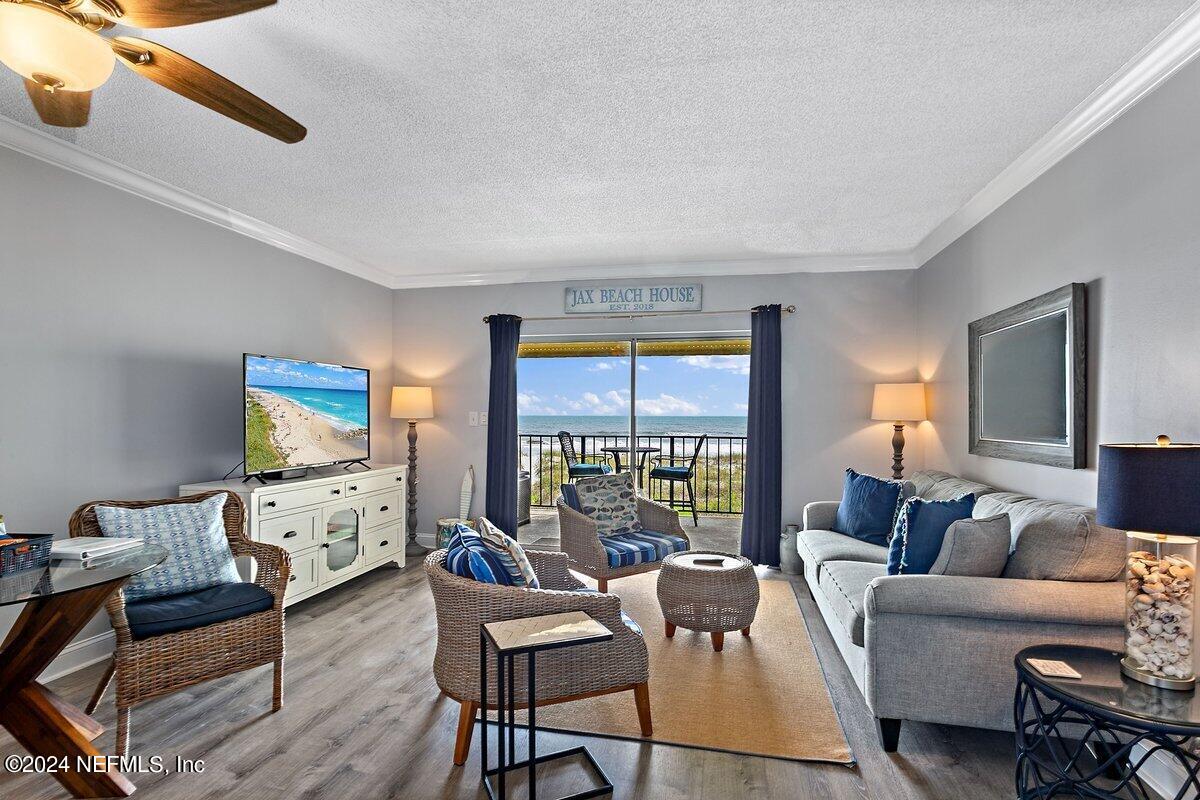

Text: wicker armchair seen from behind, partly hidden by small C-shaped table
xmin=425 ymin=551 xmax=653 ymax=765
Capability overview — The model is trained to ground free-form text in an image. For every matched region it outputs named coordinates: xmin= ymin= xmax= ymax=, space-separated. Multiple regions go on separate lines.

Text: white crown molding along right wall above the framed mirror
xmin=912 ymin=2 xmax=1200 ymax=267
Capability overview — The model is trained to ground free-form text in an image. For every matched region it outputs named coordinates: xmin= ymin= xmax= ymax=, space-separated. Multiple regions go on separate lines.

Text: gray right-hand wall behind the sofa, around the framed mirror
xmin=917 ymin=54 xmax=1200 ymax=505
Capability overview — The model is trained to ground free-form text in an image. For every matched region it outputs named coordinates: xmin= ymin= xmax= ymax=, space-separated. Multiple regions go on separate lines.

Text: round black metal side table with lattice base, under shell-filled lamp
xmin=1013 ymin=645 xmax=1200 ymax=800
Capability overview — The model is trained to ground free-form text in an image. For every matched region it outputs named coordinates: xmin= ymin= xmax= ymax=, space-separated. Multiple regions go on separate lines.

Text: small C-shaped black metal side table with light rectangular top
xmin=479 ymin=612 xmax=612 ymax=800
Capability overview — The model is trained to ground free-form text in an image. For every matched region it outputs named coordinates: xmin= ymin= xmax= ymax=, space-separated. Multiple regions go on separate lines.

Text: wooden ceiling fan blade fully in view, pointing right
xmin=109 ymin=36 xmax=307 ymax=144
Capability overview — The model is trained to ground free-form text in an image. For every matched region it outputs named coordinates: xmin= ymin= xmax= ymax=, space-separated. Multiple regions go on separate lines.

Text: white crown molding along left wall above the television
xmin=0 ymin=116 xmax=391 ymax=285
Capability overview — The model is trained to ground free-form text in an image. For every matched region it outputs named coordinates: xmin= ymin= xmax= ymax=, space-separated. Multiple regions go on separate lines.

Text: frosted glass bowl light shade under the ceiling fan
xmin=0 ymin=2 xmax=115 ymax=91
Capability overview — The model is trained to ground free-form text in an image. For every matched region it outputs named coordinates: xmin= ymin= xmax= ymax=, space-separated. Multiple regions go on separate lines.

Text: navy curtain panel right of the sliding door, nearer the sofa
xmin=742 ymin=306 xmax=784 ymax=566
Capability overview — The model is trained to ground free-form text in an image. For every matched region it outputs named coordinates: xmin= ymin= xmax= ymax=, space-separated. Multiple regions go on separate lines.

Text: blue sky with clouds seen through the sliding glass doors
xmin=517 ymin=355 xmax=750 ymax=416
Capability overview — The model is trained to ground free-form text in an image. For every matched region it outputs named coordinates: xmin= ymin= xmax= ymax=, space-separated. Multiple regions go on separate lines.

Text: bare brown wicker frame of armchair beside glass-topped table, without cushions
xmin=70 ymin=492 xmax=292 ymax=756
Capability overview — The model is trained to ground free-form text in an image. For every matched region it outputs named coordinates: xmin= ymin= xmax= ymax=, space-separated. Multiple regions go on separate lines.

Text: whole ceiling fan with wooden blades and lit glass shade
xmin=0 ymin=0 xmax=306 ymax=144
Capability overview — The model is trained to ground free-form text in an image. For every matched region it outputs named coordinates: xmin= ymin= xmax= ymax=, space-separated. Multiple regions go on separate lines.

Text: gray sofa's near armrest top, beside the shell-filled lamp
xmin=865 ymin=575 xmax=1124 ymax=626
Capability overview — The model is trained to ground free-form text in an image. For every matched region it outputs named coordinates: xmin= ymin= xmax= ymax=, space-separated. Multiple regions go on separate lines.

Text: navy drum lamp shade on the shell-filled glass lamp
xmin=1096 ymin=437 xmax=1200 ymax=536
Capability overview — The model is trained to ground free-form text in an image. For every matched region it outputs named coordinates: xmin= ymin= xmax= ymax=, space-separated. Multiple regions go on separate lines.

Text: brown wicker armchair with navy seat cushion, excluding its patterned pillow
xmin=68 ymin=492 xmax=285 ymax=756
